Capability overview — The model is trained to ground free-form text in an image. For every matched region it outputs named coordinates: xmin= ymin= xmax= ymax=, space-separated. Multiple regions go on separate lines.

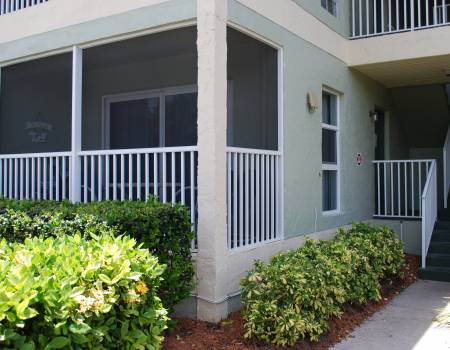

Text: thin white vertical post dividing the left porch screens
xmin=71 ymin=46 xmax=83 ymax=203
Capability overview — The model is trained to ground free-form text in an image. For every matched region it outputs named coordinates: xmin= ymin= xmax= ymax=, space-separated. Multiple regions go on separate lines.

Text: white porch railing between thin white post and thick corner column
xmin=79 ymin=146 xmax=197 ymax=230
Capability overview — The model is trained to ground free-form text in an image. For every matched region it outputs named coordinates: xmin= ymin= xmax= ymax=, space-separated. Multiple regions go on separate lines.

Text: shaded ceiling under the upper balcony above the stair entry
xmin=352 ymin=55 xmax=450 ymax=88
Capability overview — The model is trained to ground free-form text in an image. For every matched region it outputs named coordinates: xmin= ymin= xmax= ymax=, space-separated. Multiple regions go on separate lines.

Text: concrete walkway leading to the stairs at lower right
xmin=333 ymin=280 xmax=450 ymax=350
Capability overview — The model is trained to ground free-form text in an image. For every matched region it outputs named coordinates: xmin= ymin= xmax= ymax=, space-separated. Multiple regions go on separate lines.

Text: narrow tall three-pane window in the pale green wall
xmin=322 ymin=91 xmax=339 ymax=213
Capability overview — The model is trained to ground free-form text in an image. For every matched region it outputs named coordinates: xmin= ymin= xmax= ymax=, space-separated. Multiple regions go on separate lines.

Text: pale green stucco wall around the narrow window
xmin=229 ymin=0 xmax=392 ymax=238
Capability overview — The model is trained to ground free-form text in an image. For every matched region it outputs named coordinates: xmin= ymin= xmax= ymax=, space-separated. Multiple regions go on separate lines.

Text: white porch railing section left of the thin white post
xmin=0 ymin=152 xmax=71 ymax=201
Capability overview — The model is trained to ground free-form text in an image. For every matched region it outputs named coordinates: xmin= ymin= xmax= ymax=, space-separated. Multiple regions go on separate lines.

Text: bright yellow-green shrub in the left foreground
xmin=0 ymin=228 xmax=167 ymax=349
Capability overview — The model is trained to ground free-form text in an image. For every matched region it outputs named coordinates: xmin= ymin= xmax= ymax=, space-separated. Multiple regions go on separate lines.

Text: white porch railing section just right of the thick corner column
xmin=227 ymin=147 xmax=282 ymax=250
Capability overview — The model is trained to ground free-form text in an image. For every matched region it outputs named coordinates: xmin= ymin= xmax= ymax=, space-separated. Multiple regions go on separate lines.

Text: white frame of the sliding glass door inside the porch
xmin=102 ymin=85 xmax=198 ymax=149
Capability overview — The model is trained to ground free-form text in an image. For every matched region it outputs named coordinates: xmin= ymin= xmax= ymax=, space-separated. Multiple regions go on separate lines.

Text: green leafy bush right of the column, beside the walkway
xmin=241 ymin=224 xmax=404 ymax=346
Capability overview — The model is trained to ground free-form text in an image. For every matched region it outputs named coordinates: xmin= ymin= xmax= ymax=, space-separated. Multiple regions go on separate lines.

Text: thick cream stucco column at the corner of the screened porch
xmin=197 ymin=0 xmax=228 ymax=322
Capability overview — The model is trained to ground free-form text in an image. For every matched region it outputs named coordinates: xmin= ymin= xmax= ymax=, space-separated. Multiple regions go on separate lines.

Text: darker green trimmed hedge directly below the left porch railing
xmin=0 ymin=199 xmax=194 ymax=310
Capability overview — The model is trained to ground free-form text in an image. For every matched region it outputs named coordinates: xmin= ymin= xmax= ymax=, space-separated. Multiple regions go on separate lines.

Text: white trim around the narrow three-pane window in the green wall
xmin=321 ymin=87 xmax=342 ymax=216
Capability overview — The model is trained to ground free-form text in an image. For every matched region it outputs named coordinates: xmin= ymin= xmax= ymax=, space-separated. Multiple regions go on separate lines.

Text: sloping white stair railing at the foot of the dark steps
xmin=422 ymin=161 xmax=438 ymax=268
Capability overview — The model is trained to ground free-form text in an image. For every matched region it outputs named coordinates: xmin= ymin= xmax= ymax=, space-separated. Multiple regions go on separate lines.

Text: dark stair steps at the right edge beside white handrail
xmin=419 ymin=209 xmax=450 ymax=282
